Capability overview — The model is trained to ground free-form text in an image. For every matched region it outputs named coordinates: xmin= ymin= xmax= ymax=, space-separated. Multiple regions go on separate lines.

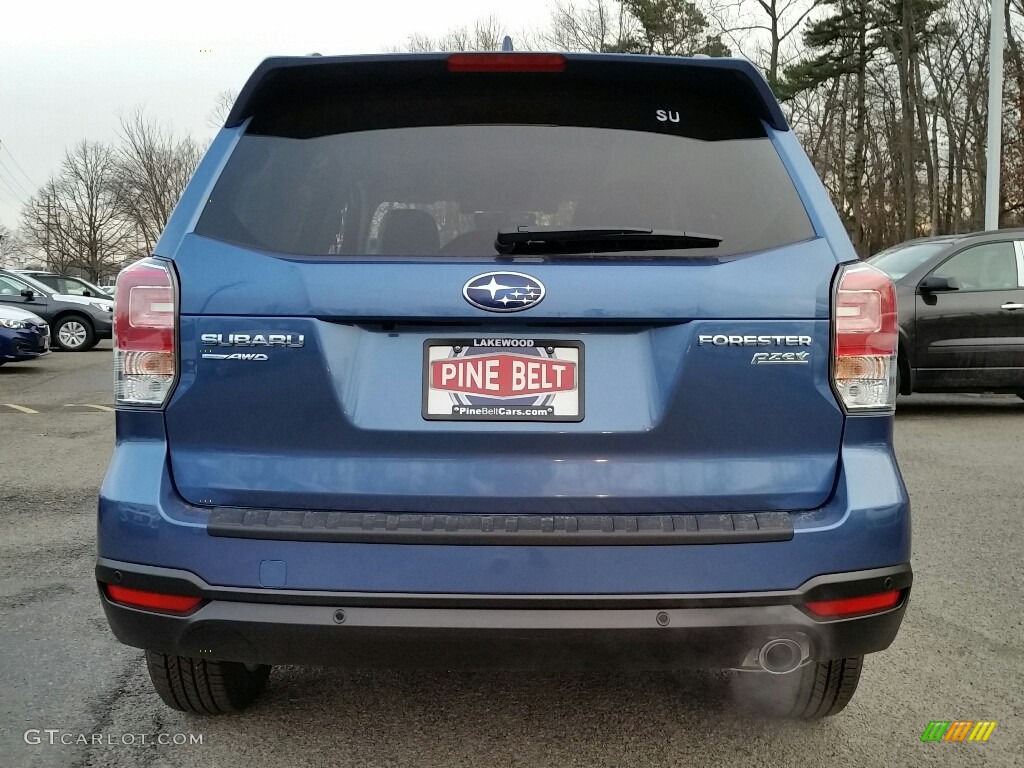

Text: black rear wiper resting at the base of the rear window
xmin=495 ymin=226 xmax=722 ymax=254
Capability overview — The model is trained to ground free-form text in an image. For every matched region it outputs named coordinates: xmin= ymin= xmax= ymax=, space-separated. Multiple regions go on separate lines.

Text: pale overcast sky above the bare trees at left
xmin=0 ymin=0 xmax=551 ymax=228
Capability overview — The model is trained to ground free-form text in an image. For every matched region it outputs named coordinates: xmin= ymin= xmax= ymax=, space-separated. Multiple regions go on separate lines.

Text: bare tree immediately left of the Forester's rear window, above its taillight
xmin=114 ymin=111 xmax=203 ymax=252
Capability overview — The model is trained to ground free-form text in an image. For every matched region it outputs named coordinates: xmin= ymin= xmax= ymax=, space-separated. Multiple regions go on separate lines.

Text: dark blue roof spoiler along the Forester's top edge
xmin=224 ymin=52 xmax=788 ymax=131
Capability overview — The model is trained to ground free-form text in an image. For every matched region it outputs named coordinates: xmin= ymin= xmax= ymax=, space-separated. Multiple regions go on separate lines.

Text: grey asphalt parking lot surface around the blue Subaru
xmin=0 ymin=342 xmax=1024 ymax=768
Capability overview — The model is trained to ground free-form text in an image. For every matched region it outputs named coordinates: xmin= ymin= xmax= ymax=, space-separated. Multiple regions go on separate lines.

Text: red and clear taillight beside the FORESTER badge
xmin=831 ymin=264 xmax=898 ymax=413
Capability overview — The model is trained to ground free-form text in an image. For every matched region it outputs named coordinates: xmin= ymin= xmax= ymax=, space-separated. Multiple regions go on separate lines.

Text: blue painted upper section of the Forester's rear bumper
xmin=97 ymin=411 xmax=910 ymax=597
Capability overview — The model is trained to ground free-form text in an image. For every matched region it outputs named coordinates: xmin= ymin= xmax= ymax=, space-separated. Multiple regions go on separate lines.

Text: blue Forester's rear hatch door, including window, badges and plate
xmin=166 ymin=57 xmax=843 ymax=515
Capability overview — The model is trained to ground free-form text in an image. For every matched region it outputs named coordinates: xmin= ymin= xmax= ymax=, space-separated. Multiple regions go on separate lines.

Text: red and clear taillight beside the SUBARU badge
xmin=114 ymin=259 xmax=177 ymax=408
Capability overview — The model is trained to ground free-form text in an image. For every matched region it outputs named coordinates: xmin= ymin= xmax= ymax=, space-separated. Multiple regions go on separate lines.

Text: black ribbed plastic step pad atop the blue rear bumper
xmin=207 ymin=507 xmax=794 ymax=546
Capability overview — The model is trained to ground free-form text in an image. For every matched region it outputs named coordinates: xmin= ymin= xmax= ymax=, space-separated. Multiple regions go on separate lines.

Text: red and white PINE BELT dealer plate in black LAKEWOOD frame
xmin=423 ymin=337 xmax=584 ymax=421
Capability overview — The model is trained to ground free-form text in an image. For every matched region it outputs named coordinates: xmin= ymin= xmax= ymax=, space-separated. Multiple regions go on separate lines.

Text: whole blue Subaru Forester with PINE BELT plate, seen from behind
xmin=96 ymin=53 xmax=911 ymax=719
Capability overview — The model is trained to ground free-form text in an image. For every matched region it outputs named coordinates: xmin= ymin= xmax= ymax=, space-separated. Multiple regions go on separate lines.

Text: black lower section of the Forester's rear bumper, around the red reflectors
xmin=96 ymin=558 xmax=912 ymax=670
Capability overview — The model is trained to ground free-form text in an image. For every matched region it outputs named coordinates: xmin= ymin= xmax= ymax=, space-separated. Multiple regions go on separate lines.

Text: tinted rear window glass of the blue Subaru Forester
xmin=196 ymin=76 xmax=814 ymax=257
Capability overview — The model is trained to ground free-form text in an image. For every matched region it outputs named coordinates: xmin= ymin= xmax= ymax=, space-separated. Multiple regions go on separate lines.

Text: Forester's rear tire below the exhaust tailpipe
xmin=733 ymin=656 xmax=864 ymax=720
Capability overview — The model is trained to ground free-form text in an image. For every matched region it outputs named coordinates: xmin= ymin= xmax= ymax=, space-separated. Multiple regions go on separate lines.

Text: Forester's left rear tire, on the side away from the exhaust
xmin=145 ymin=650 xmax=270 ymax=715
